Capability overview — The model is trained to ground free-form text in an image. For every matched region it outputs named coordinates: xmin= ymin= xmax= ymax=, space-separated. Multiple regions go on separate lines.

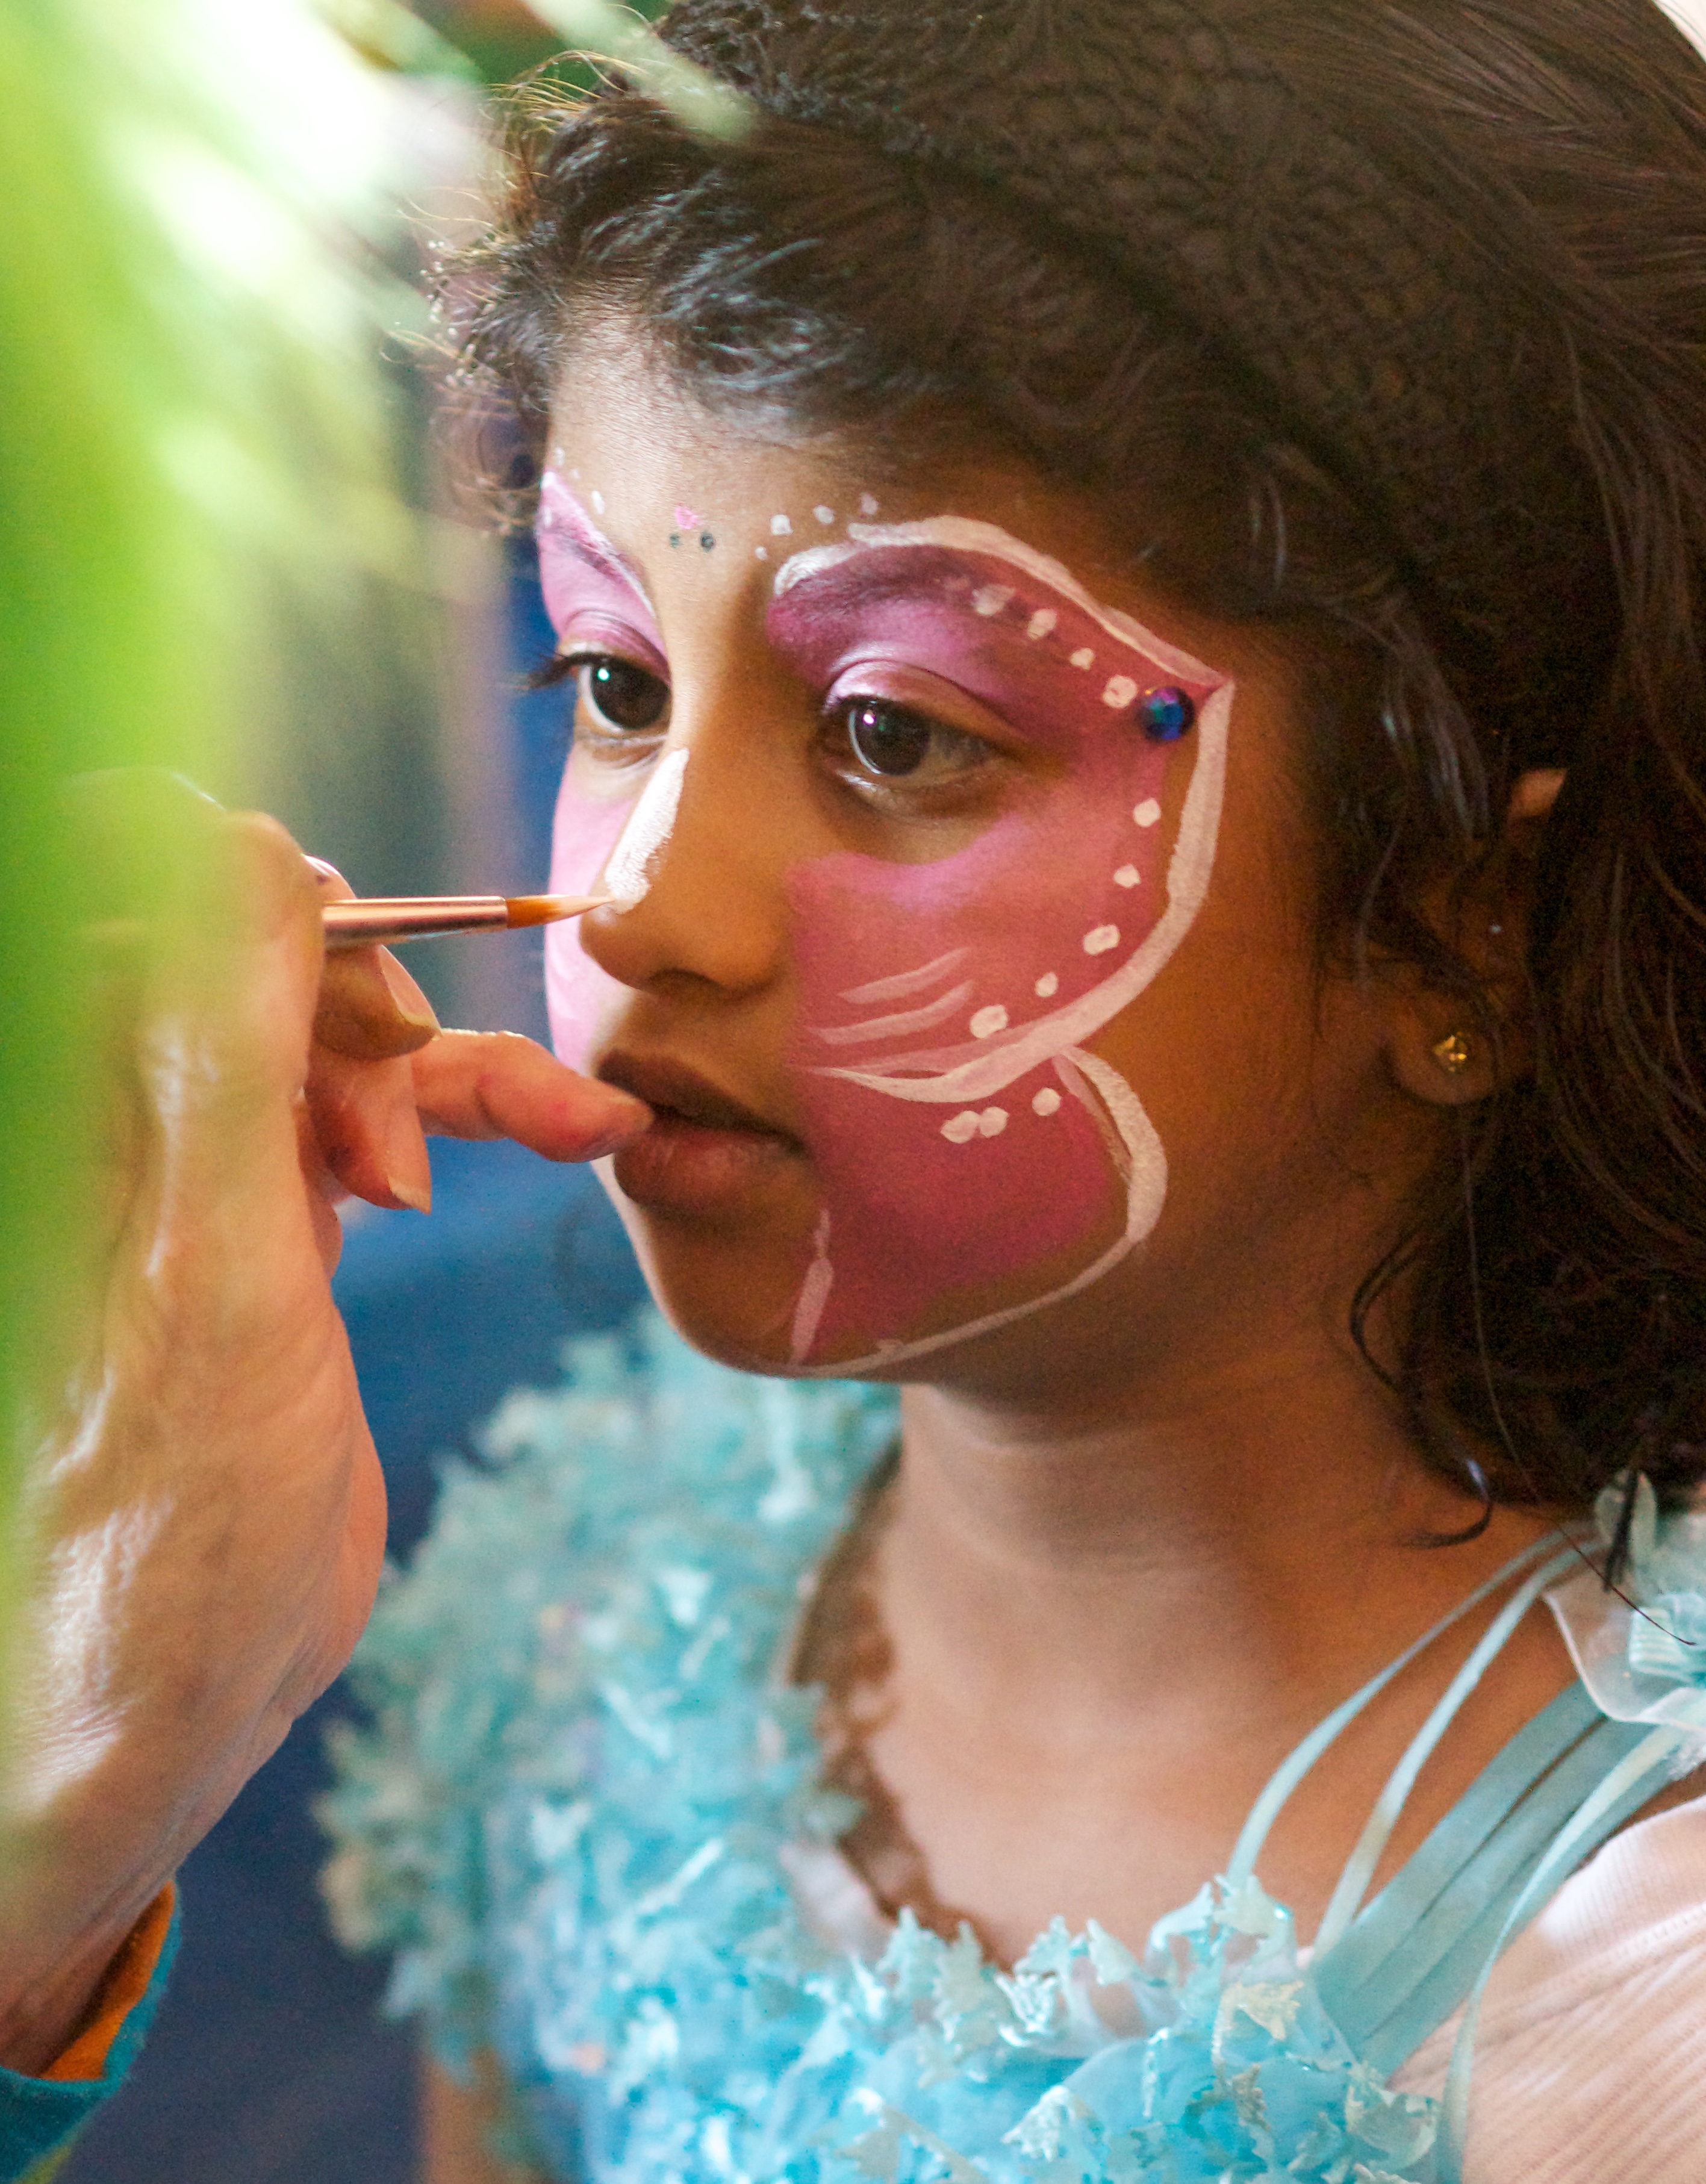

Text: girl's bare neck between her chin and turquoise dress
xmin=885 ymin=1319 xmax=1551 ymax=1741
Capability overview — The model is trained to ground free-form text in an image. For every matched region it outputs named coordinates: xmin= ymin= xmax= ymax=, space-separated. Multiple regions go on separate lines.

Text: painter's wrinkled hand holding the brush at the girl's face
xmin=0 ymin=777 xmax=649 ymax=2070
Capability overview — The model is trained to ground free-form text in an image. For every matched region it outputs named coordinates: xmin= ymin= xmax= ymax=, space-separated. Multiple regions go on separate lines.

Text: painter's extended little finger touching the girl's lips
xmin=411 ymin=1031 xmax=651 ymax=1160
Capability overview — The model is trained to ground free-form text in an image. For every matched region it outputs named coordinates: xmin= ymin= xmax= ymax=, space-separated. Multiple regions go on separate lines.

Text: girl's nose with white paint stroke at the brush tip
xmin=581 ymin=729 xmax=791 ymax=996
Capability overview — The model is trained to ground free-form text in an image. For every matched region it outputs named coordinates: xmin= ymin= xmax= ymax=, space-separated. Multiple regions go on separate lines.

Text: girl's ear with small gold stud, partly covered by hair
xmin=1387 ymin=769 xmax=1564 ymax=1107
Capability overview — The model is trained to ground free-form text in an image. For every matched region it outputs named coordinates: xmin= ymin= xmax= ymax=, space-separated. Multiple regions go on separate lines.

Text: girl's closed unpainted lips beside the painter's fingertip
xmin=599 ymin=1053 xmax=804 ymax=1215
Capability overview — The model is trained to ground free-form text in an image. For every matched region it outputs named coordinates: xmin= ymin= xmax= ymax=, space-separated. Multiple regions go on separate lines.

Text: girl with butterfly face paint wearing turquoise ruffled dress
xmin=319 ymin=0 xmax=1706 ymax=2184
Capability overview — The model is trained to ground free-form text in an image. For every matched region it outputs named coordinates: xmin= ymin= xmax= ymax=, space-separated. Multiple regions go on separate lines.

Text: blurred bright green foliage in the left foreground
xmin=0 ymin=0 xmax=417 ymax=1642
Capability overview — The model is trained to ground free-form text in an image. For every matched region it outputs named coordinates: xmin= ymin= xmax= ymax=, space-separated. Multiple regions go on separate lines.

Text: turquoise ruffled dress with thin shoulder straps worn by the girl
xmin=323 ymin=1324 xmax=1706 ymax=2184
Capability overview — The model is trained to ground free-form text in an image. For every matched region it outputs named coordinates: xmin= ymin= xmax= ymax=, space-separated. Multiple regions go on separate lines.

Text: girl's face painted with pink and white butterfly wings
xmin=540 ymin=345 xmax=1407 ymax=1383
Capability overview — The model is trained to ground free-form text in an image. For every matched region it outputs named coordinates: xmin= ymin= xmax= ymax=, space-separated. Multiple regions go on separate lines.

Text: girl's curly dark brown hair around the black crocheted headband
xmin=448 ymin=0 xmax=1706 ymax=1509
